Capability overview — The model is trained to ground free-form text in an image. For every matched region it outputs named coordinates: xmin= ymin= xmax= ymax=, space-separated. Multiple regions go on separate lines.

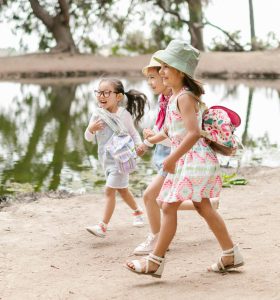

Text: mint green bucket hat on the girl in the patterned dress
xmin=154 ymin=40 xmax=200 ymax=78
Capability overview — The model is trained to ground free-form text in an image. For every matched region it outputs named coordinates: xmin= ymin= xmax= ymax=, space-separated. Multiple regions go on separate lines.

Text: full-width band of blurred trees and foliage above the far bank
xmin=0 ymin=0 xmax=279 ymax=55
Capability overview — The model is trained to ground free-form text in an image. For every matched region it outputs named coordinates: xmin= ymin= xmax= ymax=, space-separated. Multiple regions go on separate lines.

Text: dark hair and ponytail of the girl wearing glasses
xmin=101 ymin=78 xmax=147 ymax=124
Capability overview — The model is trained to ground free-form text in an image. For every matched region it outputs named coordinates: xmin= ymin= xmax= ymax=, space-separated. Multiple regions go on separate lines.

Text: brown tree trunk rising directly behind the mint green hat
xmin=187 ymin=0 xmax=205 ymax=51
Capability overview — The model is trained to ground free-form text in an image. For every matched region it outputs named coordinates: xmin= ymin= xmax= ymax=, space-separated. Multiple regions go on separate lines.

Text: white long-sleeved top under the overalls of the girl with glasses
xmin=85 ymin=107 xmax=142 ymax=145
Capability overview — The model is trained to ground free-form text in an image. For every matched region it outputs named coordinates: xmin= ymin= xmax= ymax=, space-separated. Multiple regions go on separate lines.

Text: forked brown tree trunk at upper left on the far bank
xmin=29 ymin=0 xmax=78 ymax=53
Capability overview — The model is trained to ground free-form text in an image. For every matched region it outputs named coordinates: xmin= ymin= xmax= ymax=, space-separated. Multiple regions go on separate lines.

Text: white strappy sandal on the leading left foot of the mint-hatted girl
xmin=125 ymin=253 xmax=165 ymax=278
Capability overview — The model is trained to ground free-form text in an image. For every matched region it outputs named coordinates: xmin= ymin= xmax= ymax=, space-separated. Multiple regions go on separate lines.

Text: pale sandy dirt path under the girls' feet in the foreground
xmin=0 ymin=168 xmax=280 ymax=300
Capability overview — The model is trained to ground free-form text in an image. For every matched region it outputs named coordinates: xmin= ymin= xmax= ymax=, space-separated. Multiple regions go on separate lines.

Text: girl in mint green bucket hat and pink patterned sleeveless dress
xmin=126 ymin=40 xmax=244 ymax=277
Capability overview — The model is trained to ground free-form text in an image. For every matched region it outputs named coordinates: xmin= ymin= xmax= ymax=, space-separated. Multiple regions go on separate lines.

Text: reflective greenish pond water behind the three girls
xmin=0 ymin=78 xmax=280 ymax=196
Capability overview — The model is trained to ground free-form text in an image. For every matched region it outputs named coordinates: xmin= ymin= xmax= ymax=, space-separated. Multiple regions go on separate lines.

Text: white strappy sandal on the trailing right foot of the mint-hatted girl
xmin=208 ymin=245 xmax=244 ymax=273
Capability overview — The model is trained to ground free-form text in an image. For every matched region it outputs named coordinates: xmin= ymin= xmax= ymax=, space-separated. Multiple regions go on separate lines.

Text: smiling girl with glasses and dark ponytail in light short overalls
xmin=85 ymin=78 xmax=147 ymax=238
